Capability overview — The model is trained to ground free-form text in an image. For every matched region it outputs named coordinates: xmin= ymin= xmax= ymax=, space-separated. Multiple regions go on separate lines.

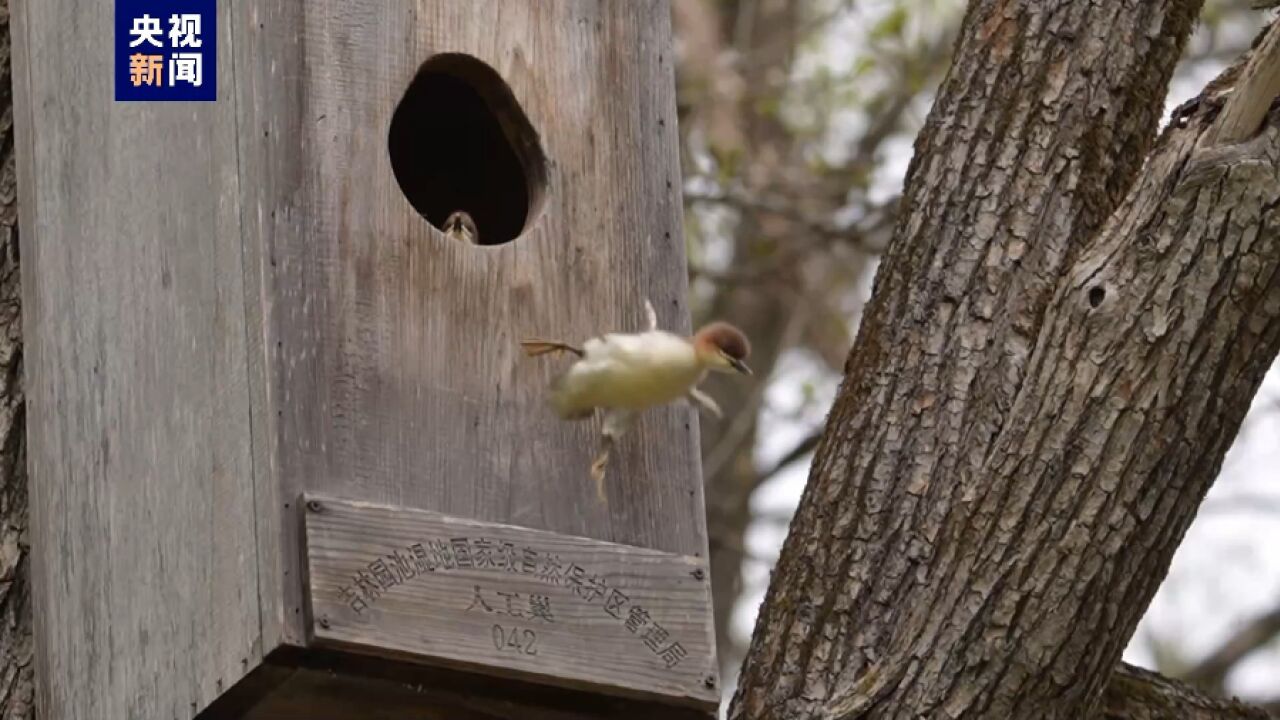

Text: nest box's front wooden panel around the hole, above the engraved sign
xmin=236 ymin=0 xmax=705 ymax=646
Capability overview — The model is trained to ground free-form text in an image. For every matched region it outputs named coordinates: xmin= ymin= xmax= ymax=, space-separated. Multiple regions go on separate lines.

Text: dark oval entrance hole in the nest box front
xmin=388 ymin=54 xmax=547 ymax=245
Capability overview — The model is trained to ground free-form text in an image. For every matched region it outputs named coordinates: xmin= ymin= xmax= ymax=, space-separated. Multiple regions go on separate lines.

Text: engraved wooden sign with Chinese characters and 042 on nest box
xmin=303 ymin=496 xmax=719 ymax=708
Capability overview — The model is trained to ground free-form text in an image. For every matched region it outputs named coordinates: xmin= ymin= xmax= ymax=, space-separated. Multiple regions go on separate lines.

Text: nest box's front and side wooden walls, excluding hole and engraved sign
xmin=15 ymin=0 xmax=705 ymax=719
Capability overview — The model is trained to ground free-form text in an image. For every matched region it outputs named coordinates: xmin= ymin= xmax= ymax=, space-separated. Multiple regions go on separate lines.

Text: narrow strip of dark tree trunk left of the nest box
xmin=0 ymin=3 xmax=36 ymax=720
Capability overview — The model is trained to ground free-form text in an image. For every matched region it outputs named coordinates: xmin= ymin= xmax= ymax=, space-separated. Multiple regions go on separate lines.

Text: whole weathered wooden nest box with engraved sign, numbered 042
xmin=13 ymin=0 xmax=719 ymax=720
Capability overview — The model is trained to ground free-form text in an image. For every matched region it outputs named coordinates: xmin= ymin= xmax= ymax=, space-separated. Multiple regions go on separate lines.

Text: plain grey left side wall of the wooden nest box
xmin=13 ymin=0 xmax=260 ymax=720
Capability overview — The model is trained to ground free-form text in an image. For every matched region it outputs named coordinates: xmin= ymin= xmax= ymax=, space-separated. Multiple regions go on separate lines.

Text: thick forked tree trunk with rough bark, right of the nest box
xmin=730 ymin=0 xmax=1280 ymax=720
